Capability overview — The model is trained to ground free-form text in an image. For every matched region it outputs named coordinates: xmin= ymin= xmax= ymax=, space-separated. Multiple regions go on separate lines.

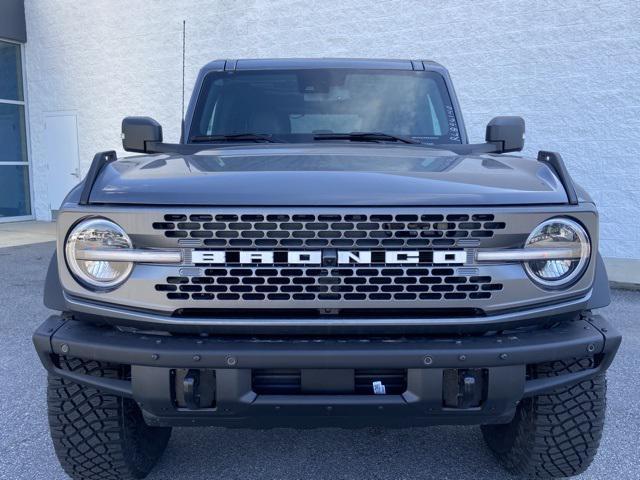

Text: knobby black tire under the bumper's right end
xmin=482 ymin=358 xmax=607 ymax=478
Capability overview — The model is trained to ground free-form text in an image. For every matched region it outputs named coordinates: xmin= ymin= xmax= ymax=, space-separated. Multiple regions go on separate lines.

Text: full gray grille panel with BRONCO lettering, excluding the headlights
xmin=58 ymin=207 xmax=597 ymax=316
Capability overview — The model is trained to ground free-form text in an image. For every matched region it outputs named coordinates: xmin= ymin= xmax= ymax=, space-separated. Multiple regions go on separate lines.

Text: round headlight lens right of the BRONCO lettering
xmin=524 ymin=218 xmax=591 ymax=287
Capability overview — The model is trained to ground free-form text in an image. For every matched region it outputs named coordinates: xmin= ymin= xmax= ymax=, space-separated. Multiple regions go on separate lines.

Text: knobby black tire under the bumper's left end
xmin=47 ymin=358 xmax=171 ymax=480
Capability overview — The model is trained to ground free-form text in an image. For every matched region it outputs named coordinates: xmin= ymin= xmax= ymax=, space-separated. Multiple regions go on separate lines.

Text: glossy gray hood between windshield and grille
xmin=91 ymin=143 xmax=567 ymax=206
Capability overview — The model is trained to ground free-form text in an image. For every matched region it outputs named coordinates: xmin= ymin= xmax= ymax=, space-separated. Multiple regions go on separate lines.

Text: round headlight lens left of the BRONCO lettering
xmin=65 ymin=218 xmax=133 ymax=289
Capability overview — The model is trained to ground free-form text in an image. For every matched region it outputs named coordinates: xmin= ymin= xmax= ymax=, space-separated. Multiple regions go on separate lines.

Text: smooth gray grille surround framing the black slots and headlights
xmin=58 ymin=204 xmax=598 ymax=316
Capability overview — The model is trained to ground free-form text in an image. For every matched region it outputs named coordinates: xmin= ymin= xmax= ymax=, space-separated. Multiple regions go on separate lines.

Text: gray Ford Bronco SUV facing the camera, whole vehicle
xmin=34 ymin=59 xmax=621 ymax=479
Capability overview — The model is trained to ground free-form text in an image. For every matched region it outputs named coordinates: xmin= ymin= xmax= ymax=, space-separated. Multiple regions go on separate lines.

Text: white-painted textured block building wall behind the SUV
xmin=26 ymin=0 xmax=640 ymax=259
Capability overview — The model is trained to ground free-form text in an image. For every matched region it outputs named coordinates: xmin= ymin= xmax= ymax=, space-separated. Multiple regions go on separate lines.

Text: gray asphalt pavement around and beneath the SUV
xmin=0 ymin=243 xmax=640 ymax=480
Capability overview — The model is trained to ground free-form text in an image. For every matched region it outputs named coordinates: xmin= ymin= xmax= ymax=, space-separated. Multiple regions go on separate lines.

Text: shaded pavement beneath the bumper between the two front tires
xmin=148 ymin=426 xmax=512 ymax=480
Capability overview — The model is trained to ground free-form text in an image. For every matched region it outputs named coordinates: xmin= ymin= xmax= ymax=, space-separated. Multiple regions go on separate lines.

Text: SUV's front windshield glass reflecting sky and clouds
xmin=189 ymin=69 xmax=461 ymax=144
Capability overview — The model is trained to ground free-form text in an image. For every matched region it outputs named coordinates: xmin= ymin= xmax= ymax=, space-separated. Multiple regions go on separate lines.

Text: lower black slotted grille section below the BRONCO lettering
xmin=155 ymin=266 xmax=503 ymax=301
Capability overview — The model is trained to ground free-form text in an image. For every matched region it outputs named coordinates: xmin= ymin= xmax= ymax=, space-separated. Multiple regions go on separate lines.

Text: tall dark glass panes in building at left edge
xmin=0 ymin=40 xmax=32 ymax=222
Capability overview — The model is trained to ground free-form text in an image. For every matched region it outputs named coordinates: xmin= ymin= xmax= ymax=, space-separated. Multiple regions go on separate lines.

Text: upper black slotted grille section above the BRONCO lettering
xmin=152 ymin=213 xmax=506 ymax=248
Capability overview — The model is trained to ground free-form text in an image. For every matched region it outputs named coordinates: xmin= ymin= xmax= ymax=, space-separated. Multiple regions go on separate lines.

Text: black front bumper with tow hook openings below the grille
xmin=34 ymin=314 xmax=621 ymax=427
